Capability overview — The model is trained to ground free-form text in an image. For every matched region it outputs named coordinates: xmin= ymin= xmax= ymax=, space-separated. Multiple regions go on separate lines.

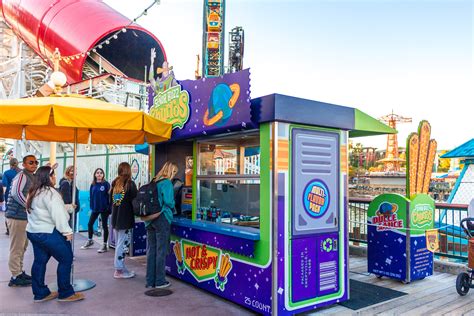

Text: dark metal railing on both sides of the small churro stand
xmin=349 ymin=198 xmax=468 ymax=260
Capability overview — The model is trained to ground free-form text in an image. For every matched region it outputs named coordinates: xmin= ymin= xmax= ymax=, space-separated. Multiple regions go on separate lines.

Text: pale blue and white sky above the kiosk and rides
xmin=105 ymin=0 xmax=474 ymax=149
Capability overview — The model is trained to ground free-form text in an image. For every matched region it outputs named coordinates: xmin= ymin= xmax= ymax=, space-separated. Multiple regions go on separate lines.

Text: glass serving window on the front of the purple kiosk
xmin=196 ymin=133 xmax=260 ymax=227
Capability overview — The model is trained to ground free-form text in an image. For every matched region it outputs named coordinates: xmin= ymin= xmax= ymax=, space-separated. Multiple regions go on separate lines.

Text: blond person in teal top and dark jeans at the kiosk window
xmin=142 ymin=161 xmax=178 ymax=288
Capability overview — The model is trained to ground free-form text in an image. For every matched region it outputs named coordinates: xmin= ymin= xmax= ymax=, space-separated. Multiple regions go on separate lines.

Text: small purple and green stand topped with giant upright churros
xmin=367 ymin=121 xmax=438 ymax=283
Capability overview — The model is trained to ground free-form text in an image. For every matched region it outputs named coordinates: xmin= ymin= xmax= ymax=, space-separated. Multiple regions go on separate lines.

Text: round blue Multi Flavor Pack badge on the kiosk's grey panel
xmin=303 ymin=180 xmax=329 ymax=217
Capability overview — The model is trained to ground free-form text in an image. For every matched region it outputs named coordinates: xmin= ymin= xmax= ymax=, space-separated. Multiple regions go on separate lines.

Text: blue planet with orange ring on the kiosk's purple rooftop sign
xmin=203 ymin=83 xmax=240 ymax=126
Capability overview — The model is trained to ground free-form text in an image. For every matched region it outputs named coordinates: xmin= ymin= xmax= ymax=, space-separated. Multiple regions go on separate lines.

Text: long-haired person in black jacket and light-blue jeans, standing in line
xmin=110 ymin=162 xmax=138 ymax=279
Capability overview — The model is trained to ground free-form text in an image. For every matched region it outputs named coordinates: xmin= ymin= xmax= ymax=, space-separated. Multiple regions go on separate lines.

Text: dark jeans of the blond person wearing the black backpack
xmin=146 ymin=214 xmax=171 ymax=286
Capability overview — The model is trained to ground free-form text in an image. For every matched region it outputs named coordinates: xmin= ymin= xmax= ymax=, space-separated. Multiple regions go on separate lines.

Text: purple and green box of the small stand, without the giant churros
xmin=367 ymin=194 xmax=434 ymax=282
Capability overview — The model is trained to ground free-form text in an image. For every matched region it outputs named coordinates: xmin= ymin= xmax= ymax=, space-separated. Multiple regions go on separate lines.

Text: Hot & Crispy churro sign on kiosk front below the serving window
xmin=173 ymin=240 xmax=232 ymax=291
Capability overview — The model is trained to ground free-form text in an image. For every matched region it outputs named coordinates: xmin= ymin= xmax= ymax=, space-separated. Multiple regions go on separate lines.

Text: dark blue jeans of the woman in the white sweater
xmin=27 ymin=229 xmax=74 ymax=300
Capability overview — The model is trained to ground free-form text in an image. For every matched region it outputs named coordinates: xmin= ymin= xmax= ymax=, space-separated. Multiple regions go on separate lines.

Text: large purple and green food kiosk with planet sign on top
xmin=150 ymin=69 xmax=394 ymax=315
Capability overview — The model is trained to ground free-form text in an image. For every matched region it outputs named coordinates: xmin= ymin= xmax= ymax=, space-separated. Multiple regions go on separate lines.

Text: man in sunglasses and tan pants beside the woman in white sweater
xmin=5 ymin=155 xmax=39 ymax=286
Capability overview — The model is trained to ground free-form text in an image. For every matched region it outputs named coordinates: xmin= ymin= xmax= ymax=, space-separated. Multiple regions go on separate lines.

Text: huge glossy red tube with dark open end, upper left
xmin=0 ymin=0 xmax=166 ymax=83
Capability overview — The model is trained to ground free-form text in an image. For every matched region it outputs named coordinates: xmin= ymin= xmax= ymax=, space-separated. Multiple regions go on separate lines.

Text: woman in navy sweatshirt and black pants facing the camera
xmin=81 ymin=168 xmax=110 ymax=253
